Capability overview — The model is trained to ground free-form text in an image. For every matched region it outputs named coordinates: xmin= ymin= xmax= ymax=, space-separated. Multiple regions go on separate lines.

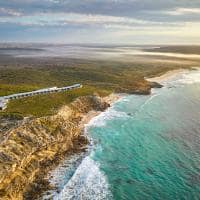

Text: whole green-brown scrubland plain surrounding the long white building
xmin=0 ymin=56 xmax=194 ymax=116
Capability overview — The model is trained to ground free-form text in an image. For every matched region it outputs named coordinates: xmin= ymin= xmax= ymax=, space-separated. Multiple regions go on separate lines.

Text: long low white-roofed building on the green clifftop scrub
xmin=0 ymin=84 xmax=82 ymax=110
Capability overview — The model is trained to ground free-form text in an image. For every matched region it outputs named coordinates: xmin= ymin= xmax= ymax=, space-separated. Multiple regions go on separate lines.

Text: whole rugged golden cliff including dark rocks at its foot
xmin=0 ymin=95 xmax=111 ymax=200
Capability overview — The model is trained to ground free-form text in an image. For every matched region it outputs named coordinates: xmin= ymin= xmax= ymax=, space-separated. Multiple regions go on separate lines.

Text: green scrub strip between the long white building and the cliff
xmin=1 ymin=86 xmax=110 ymax=118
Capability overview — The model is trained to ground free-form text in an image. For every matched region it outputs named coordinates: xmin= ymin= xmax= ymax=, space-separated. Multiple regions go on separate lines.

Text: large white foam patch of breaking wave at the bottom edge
xmin=54 ymin=156 xmax=112 ymax=200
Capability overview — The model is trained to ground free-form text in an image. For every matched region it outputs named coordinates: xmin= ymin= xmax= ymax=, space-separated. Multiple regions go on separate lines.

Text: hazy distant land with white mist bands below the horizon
xmin=0 ymin=43 xmax=200 ymax=62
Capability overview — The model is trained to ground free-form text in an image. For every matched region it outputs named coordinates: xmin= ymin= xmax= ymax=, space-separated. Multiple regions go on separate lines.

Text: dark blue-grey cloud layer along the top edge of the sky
xmin=0 ymin=0 xmax=200 ymax=17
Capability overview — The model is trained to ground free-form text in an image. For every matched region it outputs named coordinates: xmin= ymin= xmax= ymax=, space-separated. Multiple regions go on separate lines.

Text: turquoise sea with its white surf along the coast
xmin=55 ymin=71 xmax=200 ymax=200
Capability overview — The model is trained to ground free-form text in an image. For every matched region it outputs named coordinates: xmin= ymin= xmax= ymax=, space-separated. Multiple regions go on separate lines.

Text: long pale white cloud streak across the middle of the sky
xmin=0 ymin=13 xmax=167 ymax=26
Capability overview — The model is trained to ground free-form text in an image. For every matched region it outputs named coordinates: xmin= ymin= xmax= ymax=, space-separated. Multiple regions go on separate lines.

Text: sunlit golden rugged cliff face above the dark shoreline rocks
xmin=0 ymin=96 xmax=109 ymax=200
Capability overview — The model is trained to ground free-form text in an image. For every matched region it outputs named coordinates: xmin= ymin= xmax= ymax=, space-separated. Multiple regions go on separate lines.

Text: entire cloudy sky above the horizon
xmin=0 ymin=0 xmax=200 ymax=44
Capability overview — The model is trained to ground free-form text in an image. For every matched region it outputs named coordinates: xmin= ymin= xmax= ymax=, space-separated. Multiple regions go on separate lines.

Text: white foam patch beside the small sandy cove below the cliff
xmin=86 ymin=107 xmax=128 ymax=128
